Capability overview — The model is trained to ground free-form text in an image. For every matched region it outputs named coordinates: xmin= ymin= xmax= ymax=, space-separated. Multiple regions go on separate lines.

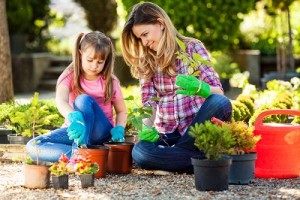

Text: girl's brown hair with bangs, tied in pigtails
xmin=58 ymin=31 xmax=115 ymax=102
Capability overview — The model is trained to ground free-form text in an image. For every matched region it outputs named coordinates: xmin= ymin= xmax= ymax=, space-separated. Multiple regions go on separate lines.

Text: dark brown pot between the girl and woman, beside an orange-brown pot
xmin=104 ymin=142 xmax=134 ymax=174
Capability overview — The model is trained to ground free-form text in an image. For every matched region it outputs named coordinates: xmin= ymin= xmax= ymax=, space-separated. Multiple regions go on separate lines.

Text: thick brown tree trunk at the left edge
xmin=0 ymin=0 xmax=14 ymax=103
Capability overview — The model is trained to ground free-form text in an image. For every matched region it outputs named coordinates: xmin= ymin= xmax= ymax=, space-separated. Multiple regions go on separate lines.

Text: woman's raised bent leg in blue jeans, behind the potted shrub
xmin=176 ymin=94 xmax=232 ymax=150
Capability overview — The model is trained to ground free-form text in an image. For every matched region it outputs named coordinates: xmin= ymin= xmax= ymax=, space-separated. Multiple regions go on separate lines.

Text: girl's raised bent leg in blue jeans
xmin=74 ymin=94 xmax=112 ymax=145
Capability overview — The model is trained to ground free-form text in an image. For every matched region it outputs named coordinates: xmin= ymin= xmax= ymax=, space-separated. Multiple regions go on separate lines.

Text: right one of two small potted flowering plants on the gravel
xmin=69 ymin=154 xmax=99 ymax=188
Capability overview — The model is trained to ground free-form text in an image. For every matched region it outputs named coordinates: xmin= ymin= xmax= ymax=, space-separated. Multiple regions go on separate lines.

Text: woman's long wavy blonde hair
xmin=121 ymin=2 xmax=185 ymax=78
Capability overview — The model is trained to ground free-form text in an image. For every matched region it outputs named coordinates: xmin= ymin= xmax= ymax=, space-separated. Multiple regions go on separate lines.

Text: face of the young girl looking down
xmin=81 ymin=47 xmax=105 ymax=80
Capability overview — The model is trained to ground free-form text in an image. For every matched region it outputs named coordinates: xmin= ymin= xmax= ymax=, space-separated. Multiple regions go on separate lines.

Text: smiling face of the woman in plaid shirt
xmin=132 ymin=23 xmax=164 ymax=51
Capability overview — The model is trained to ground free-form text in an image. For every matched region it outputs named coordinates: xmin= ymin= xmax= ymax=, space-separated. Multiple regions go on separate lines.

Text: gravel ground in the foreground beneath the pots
xmin=0 ymin=163 xmax=300 ymax=200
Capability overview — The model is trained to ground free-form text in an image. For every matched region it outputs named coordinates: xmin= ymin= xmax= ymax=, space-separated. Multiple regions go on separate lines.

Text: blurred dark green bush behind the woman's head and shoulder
xmin=123 ymin=0 xmax=256 ymax=51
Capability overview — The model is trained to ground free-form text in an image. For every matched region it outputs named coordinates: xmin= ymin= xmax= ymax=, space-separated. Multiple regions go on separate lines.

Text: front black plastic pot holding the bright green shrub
xmin=191 ymin=156 xmax=232 ymax=191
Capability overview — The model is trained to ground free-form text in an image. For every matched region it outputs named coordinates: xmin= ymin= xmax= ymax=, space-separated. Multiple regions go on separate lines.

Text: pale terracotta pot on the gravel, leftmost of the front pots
xmin=24 ymin=164 xmax=50 ymax=188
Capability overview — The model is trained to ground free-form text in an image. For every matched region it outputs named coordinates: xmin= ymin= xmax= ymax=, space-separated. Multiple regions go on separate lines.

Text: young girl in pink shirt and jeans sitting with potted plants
xmin=26 ymin=31 xmax=127 ymax=162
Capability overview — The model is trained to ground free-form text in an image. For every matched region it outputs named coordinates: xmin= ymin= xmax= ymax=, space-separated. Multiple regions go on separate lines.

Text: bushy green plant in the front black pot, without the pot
xmin=189 ymin=121 xmax=235 ymax=160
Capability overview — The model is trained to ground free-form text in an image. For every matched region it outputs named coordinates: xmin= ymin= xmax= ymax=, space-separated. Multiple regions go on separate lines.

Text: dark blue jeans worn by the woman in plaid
xmin=132 ymin=94 xmax=232 ymax=173
